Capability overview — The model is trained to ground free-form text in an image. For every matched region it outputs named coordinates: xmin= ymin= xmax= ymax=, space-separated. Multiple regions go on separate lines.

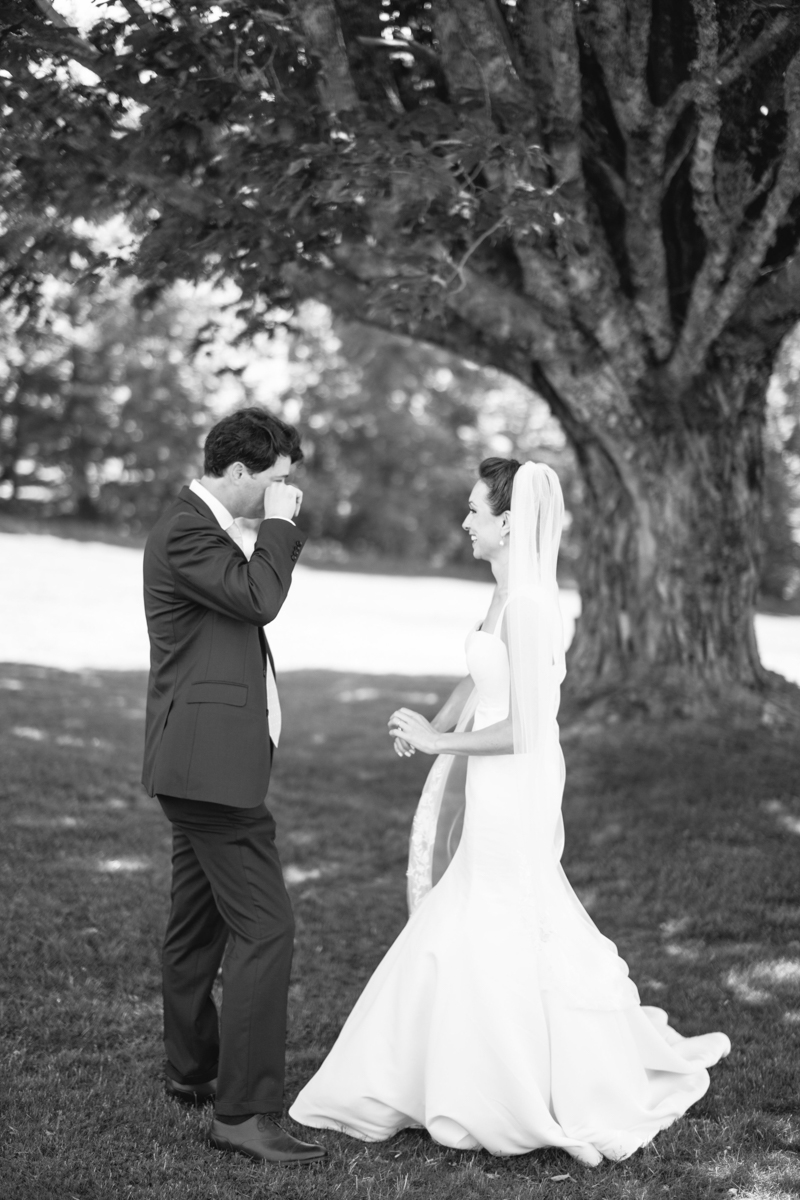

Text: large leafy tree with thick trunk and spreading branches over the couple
xmin=0 ymin=0 xmax=800 ymax=703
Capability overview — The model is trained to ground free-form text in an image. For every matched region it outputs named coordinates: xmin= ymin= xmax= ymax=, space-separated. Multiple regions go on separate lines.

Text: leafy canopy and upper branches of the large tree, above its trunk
xmin=1 ymin=0 xmax=800 ymax=367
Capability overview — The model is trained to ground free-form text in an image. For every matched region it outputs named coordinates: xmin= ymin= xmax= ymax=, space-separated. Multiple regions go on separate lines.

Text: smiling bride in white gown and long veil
xmin=290 ymin=458 xmax=730 ymax=1165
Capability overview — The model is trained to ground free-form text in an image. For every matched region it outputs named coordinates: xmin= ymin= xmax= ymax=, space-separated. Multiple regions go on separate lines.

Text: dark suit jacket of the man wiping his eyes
xmin=142 ymin=487 xmax=306 ymax=808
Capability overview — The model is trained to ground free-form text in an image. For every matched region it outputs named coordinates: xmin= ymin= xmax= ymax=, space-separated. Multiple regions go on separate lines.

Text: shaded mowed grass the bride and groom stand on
xmin=0 ymin=665 xmax=800 ymax=1200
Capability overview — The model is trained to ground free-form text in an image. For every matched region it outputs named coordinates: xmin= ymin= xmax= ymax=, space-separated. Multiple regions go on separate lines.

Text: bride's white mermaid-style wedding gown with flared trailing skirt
xmin=290 ymin=629 xmax=730 ymax=1165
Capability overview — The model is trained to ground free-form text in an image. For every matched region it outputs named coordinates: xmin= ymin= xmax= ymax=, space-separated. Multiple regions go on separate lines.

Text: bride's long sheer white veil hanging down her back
xmin=506 ymin=462 xmax=638 ymax=1009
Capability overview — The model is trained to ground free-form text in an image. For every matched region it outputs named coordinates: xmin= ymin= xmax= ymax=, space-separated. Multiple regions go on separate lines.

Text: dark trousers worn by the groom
xmin=158 ymin=796 xmax=294 ymax=1116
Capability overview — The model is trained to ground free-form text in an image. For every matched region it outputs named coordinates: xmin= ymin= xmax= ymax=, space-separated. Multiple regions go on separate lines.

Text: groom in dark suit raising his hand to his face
xmin=143 ymin=408 xmax=325 ymax=1163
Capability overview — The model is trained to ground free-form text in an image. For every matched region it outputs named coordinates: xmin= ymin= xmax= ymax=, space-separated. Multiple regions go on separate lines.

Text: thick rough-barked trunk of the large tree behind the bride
xmin=556 ymin=367 xmax=769 ymax=709
